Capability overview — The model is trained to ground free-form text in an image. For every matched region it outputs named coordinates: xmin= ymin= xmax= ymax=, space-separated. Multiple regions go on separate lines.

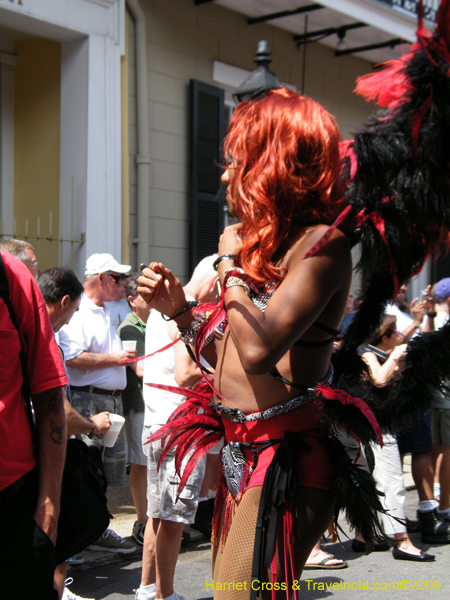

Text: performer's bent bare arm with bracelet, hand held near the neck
xmin=218 ymin=226 xmax=351 ymax=375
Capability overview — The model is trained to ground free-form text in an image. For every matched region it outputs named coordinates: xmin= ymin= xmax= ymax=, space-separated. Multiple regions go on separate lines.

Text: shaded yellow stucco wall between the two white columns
xmin=14 ymin=38 xmax=61 ymax=270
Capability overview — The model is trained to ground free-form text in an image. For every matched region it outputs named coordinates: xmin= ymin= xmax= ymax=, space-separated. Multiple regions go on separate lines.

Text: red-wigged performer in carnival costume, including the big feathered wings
xmin=139 ymin=0 xmax=450 ymax=600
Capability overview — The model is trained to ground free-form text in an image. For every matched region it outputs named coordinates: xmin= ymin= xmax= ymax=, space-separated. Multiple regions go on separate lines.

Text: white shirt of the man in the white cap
xmin=59 ymin=294 xmax=127 ymax=390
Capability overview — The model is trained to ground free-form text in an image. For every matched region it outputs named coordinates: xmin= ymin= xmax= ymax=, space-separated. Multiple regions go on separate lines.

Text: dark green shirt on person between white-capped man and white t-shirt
xmin=119 ymin=312 xmax=145 ymax=415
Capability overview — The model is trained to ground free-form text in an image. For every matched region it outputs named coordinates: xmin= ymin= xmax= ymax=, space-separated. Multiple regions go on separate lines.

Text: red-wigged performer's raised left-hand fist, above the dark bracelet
xmin=137 ymin=263 xmax=187 ymax=317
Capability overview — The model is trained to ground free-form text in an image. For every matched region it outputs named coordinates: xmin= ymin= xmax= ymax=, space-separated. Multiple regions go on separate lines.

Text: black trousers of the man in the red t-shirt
xmin=0 ymin=469 xmax=58 ymax=600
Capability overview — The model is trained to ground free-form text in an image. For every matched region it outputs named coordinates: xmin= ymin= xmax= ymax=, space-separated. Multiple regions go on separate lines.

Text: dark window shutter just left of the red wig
xmin=189 ymin=79 xmax=225 ymax=273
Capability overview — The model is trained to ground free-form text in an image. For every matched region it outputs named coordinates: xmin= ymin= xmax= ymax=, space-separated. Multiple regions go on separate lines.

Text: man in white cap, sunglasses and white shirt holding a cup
xmin=59 ymin=253 xmax=136 ymax=554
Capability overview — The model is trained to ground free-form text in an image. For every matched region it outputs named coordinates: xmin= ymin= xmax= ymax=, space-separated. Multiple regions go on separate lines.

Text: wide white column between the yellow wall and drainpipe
xmin=60 ymin=35 xmax=121 ymax=275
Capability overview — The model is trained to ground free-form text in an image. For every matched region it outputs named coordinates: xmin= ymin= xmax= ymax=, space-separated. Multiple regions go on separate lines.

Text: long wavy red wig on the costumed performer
xmin=224 ymin=88 xmax=342 ymax=286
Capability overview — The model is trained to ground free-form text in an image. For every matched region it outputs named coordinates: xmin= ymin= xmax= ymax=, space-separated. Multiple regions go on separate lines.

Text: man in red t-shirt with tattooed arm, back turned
xmin=0 ymin=252 xmax=68 ymax=600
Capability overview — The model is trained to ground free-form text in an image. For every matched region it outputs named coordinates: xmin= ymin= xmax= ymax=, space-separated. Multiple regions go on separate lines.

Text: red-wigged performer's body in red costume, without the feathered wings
xmin=140 ymin=89 xmax=378 ymax=598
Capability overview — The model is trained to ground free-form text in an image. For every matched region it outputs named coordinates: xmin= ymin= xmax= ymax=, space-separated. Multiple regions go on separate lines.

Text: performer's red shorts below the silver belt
xmin=223 ymin=401 xmax=335 ymax=491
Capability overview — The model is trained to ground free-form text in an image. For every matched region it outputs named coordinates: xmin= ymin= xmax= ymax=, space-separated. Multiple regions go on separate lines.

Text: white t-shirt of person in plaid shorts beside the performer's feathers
xmin=143 ymin=309 xmax=186 ymax=427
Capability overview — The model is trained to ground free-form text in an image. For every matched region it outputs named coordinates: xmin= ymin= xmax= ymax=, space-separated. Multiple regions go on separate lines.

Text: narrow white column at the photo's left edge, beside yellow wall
xmin=0 ymin=54 xmax=17 ymax=236
